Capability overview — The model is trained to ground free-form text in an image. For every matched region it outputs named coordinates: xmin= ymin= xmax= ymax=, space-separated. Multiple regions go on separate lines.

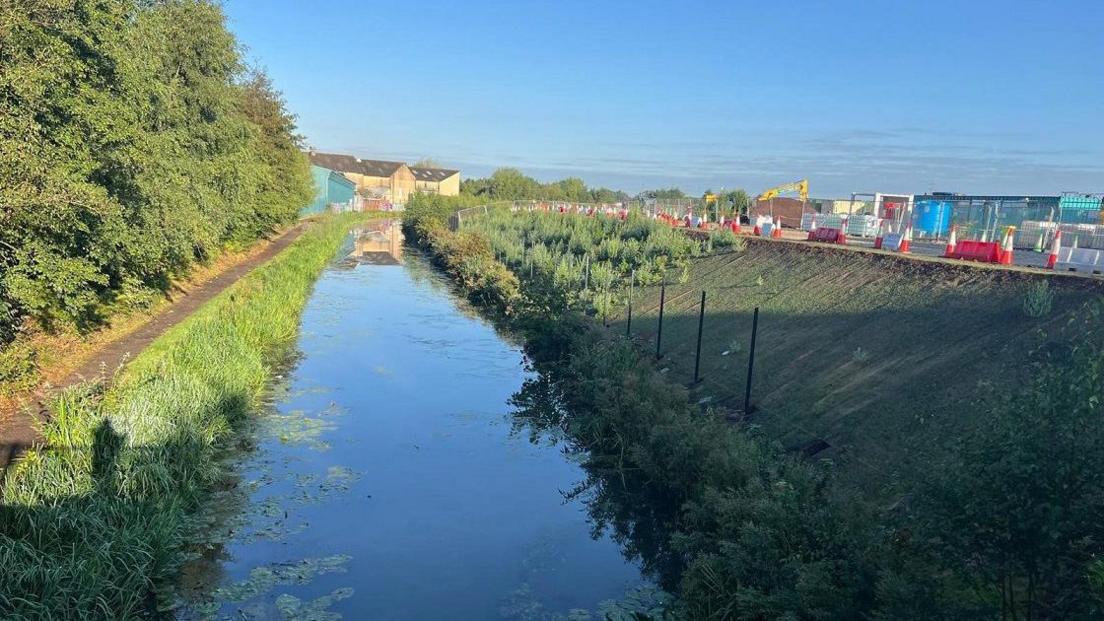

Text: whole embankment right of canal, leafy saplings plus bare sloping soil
xmin=430 ymin=210 xmax=1104 ymax=487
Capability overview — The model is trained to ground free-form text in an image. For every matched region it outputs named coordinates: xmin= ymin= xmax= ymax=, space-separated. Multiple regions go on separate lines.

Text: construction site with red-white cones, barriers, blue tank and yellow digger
xmin=639 ymin=179 xmax=1104 ymax=275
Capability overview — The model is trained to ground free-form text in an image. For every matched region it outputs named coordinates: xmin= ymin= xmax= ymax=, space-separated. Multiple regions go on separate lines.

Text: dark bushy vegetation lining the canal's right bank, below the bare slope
xmin=410 ymin=202 xmax=1104 ymax=620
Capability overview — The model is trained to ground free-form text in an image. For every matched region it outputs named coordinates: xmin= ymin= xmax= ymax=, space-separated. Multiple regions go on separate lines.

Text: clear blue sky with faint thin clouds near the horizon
xmin=225 ymin=0 xmax=1104 ymax=197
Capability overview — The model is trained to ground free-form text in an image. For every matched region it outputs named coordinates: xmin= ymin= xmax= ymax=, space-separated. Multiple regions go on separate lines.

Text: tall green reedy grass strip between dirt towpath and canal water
xmin=0 ymin=211 xmax=370 ymax=619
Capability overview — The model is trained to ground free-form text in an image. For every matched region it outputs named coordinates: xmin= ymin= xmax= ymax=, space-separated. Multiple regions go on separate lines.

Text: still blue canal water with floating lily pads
xmin=177 ymin=222 xmax=660 ymax=620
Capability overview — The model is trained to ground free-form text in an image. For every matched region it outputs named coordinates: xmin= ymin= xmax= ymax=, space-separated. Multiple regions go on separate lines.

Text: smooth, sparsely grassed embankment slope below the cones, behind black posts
xmin=609 ymin=240 xmax=1104 ymax=482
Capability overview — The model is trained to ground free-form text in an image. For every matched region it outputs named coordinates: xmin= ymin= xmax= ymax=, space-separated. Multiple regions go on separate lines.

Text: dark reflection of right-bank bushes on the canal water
xmin=510 ymin=373 xmax=683 ymax=591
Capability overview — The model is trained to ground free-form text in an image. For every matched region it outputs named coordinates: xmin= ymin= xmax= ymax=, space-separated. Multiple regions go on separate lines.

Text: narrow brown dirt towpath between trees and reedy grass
xmin=0 ymin=222 xmax=310 ymax=468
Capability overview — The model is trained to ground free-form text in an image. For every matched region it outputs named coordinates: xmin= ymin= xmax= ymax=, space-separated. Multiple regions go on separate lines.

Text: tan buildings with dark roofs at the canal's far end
xmin=310 ymin=151 xmax=460 ymax=206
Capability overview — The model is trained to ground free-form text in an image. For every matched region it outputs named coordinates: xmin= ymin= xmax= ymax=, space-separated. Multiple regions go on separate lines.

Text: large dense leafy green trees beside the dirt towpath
xmin=0 ymin=0 xmax=311 ymax=345
